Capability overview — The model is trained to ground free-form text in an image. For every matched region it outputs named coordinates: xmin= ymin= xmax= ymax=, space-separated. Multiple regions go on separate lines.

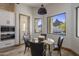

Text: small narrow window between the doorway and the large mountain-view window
xmin=34 ymin=18 xmax=42 ymax=33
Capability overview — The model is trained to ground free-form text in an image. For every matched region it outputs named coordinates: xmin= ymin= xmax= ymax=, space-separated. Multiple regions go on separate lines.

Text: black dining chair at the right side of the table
xmin=53 ymin=37 xmax=64 ymax=56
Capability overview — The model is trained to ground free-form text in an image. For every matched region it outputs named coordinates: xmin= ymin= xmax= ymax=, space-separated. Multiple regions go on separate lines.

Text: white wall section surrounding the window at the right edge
xmin=71 ymin=3 xmax=79 ymax=54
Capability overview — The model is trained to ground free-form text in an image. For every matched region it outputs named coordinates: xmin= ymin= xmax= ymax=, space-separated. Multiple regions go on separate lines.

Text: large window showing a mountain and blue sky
xmin=48 ymin=13 xmax=66 ymax=35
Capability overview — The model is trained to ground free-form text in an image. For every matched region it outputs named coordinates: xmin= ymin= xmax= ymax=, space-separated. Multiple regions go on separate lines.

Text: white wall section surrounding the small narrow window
xmin=32 ymin=7 xmax=47 ymax=38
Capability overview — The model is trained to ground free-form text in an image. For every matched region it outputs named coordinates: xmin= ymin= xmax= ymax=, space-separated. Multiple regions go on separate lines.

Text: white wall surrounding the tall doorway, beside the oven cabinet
xmin=16 ymin=4 xmax=32 ymax=44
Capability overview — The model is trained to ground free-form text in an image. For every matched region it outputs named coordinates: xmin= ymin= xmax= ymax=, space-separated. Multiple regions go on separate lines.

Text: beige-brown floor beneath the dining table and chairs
xmin=0 ymin=45 xmax=75 ymax=56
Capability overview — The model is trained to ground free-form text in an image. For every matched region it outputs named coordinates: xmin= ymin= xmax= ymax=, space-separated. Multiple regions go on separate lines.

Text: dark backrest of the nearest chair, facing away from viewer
xmin=30 ymin=42 xmax=43 ymax=56
